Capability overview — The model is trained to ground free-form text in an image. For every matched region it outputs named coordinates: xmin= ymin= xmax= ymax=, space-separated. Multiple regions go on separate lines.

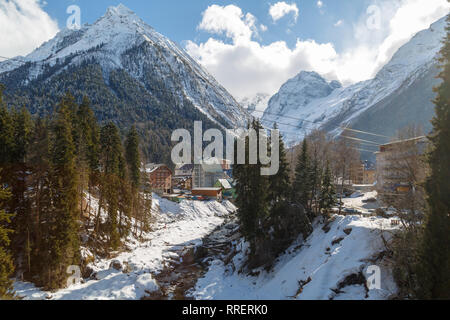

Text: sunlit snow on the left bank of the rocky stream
xmin=15 ymin=195 xmax=236 ymax=300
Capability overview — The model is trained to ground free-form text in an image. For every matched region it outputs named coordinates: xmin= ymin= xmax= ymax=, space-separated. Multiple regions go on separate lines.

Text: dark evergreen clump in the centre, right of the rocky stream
xmin=233 ymin=120 xmax=336 ymax=269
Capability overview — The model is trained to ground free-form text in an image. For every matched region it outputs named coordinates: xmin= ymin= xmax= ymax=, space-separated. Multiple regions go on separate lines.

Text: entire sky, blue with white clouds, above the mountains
xmin=0 ymin=0 xmax=450 ymax=99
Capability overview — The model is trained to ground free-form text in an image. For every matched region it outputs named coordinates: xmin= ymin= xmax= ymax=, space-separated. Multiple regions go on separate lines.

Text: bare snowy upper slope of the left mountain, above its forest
xmin=0 ymin=5 xmax=246 ymax=126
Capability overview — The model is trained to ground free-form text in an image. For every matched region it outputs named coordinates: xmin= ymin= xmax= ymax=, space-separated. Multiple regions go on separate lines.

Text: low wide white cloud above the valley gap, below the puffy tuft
xmin=187 ymin=38 xmax=336 ymax=98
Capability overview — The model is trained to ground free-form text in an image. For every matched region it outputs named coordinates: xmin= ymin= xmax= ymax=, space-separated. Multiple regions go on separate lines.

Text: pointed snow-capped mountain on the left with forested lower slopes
xmin=0 ymin=5 xmax=247 ymax=154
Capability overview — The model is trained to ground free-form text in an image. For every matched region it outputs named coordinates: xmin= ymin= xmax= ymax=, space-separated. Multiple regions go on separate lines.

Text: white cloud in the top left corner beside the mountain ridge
xmin=0 ymin=0 xmax=58 ymax=57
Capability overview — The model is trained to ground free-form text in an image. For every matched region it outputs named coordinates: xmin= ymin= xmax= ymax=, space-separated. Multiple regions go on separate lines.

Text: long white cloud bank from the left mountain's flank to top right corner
xmin=186 ymin=0 xmax=450 ymax=98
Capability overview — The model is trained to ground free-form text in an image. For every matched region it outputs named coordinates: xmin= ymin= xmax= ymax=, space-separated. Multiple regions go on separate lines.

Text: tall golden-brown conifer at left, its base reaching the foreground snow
xmin=41 ymin=100 xmax=80 ymax=289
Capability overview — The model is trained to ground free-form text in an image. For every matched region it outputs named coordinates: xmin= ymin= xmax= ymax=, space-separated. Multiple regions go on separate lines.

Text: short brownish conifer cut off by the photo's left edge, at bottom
xmin=0 ymin=178 xmax=14 ymax=300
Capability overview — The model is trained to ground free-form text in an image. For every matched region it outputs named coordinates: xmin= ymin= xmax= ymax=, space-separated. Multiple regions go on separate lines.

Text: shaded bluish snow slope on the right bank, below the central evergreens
xmin=191 ymin=212 xmax=395 ymax=300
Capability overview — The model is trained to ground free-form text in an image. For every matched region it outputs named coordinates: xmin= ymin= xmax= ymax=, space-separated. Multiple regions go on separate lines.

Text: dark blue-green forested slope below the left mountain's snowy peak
xmin=0 ymin=58 xmax=221 ymax=163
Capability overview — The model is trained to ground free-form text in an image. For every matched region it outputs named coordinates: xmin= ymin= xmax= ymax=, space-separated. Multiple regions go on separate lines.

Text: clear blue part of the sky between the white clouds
xmin=45 ymin=0 xmax=373 ymax=50
